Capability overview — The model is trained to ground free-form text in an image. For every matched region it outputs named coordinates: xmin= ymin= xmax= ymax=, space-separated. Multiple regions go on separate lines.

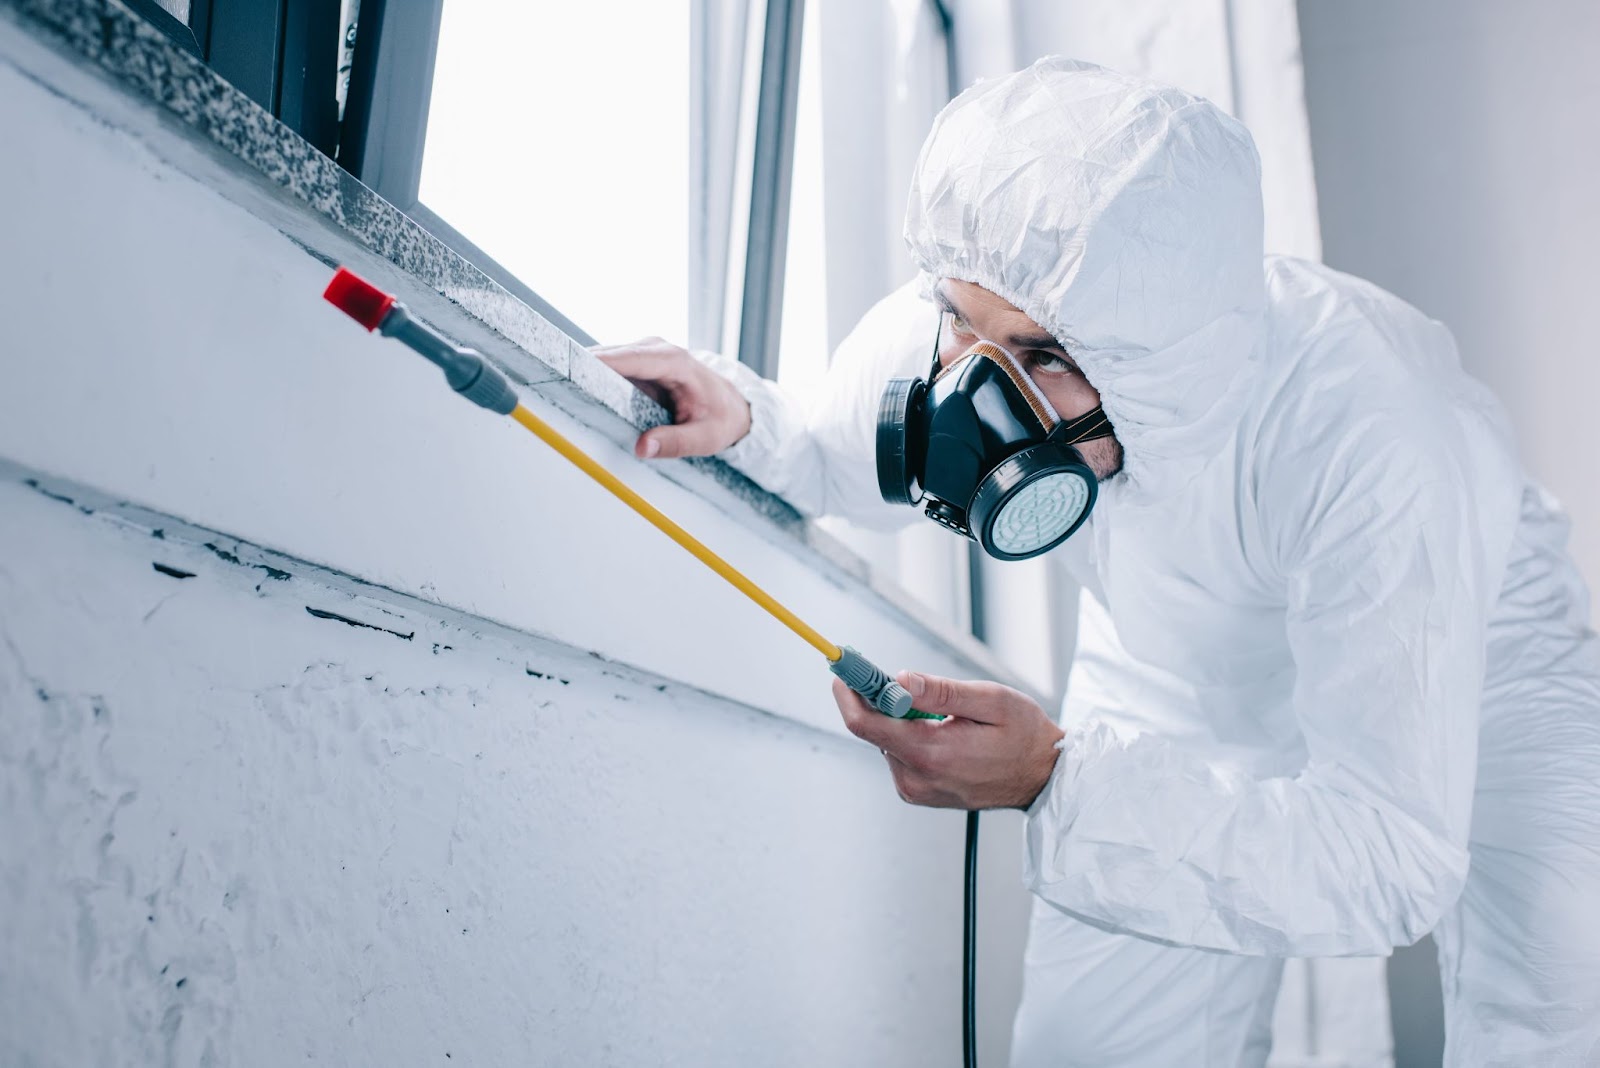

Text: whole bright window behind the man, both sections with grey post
xmin=339 ymin=0 xmax=1070 ymax=692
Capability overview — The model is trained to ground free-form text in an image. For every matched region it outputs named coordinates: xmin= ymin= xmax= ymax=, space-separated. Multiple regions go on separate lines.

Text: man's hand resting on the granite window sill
xmin=589 ymin=337 xmax=750 ymax=460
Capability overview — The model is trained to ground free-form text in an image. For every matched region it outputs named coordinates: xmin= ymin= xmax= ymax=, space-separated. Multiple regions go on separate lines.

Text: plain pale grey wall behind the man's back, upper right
xmin=1301 ymin=0 xmax=1600 ymax=601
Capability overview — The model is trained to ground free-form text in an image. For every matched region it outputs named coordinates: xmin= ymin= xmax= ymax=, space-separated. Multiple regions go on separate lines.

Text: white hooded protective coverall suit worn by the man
xmin=712 ymin=59 xmax=1600 ymax=1068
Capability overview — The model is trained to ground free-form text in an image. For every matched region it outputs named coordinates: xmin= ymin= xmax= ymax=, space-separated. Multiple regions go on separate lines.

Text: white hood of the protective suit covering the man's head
xmin=906 ymin=58 xmax=1266 ymax=491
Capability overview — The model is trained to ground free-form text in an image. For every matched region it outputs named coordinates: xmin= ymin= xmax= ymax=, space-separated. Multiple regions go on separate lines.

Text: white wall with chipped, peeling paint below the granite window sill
xmin=0 ymin=11 xmax=1018 ymax=1066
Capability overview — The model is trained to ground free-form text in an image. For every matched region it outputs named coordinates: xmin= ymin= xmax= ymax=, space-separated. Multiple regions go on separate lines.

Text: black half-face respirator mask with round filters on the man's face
xmin=877 ymin=315 xmax=1112 ymax=560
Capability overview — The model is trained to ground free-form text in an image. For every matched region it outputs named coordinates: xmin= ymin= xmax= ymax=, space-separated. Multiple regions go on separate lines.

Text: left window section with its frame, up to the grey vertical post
xmin=339 ymin=0 xmax=762 ymax=347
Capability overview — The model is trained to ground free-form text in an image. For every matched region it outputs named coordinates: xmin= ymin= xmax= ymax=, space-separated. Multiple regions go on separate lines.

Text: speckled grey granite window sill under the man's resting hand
xmin=0 ymin=0 xmax=1018 ymax=684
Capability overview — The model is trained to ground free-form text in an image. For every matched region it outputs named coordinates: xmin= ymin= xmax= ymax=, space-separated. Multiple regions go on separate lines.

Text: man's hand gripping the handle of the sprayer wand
xmin=834 ymin=671 xmax=1061 ymax=809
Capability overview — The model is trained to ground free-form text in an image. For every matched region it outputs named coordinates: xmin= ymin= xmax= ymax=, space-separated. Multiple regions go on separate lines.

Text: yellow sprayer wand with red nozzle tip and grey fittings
xmin=323 ymin=267 xmax=944 ymax=719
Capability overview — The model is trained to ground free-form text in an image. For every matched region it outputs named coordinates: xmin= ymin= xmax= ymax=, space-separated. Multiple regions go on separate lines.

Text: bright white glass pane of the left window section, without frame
xmin=418 ymin=0 xmax=690 ymax=342
